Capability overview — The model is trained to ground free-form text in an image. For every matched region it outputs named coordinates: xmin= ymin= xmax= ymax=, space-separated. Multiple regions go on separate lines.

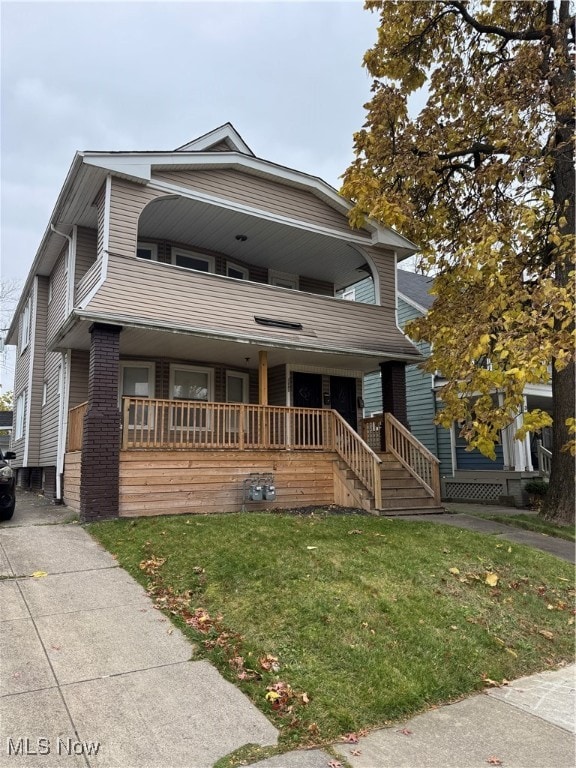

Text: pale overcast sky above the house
xmin=0 ymin=0 xmax=378 ymax=389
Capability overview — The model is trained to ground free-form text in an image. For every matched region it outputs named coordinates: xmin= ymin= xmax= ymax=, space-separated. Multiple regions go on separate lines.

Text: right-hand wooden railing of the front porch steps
xmin=384 ymin=413 xmax=441 ymax=505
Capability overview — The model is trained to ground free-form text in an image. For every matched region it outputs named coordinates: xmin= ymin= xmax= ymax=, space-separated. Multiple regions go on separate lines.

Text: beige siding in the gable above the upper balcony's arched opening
xmin=152 ymin=169 xmax=369 ymax=240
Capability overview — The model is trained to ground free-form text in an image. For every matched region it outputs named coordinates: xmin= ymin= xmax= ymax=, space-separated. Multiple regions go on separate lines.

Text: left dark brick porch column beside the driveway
xmin=80 ymin=323 xmax=122 ymax=521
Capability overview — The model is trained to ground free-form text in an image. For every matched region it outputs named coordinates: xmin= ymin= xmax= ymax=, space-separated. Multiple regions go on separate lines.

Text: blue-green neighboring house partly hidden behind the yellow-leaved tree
xmin=341 ymin=269 xmax=552 ymax=506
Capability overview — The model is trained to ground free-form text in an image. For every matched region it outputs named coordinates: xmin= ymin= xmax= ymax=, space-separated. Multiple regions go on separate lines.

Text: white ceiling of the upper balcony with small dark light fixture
xmin=138 ymin=197 xmax=370 ymax=289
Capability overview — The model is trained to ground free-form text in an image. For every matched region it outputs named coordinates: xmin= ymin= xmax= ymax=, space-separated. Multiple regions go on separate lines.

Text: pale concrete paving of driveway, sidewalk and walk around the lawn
xmin=0 ymin=494 xmax=576 ymax=768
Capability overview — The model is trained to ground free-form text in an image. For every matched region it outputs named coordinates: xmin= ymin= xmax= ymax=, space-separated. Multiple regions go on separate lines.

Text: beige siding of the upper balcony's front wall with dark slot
xmin=87 ymin=256 xmax=416 ymax=355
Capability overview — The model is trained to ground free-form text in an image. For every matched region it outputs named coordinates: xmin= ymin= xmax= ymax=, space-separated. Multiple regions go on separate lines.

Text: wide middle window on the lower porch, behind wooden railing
xmin=170 ymin=365 xmax=214 ymax=429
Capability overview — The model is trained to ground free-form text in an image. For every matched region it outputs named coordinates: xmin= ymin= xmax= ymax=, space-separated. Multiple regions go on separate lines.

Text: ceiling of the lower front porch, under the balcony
xmin=53 ymin=321 xmax=396 ymax=373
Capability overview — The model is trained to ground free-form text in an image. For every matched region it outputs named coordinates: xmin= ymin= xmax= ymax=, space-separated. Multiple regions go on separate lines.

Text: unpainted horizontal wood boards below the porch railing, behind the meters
xmin=120 ymin=451 xmax=336 ymax=517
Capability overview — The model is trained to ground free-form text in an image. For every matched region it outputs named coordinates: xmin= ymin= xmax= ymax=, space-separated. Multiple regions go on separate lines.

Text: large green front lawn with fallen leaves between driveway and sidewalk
xmin=89 ymin=511 xmax=574 ymax=748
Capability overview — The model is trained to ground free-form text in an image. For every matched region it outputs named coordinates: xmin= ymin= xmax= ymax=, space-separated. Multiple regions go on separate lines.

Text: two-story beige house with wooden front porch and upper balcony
xmin=8 ymin=124 xmax=439 ymax=520
